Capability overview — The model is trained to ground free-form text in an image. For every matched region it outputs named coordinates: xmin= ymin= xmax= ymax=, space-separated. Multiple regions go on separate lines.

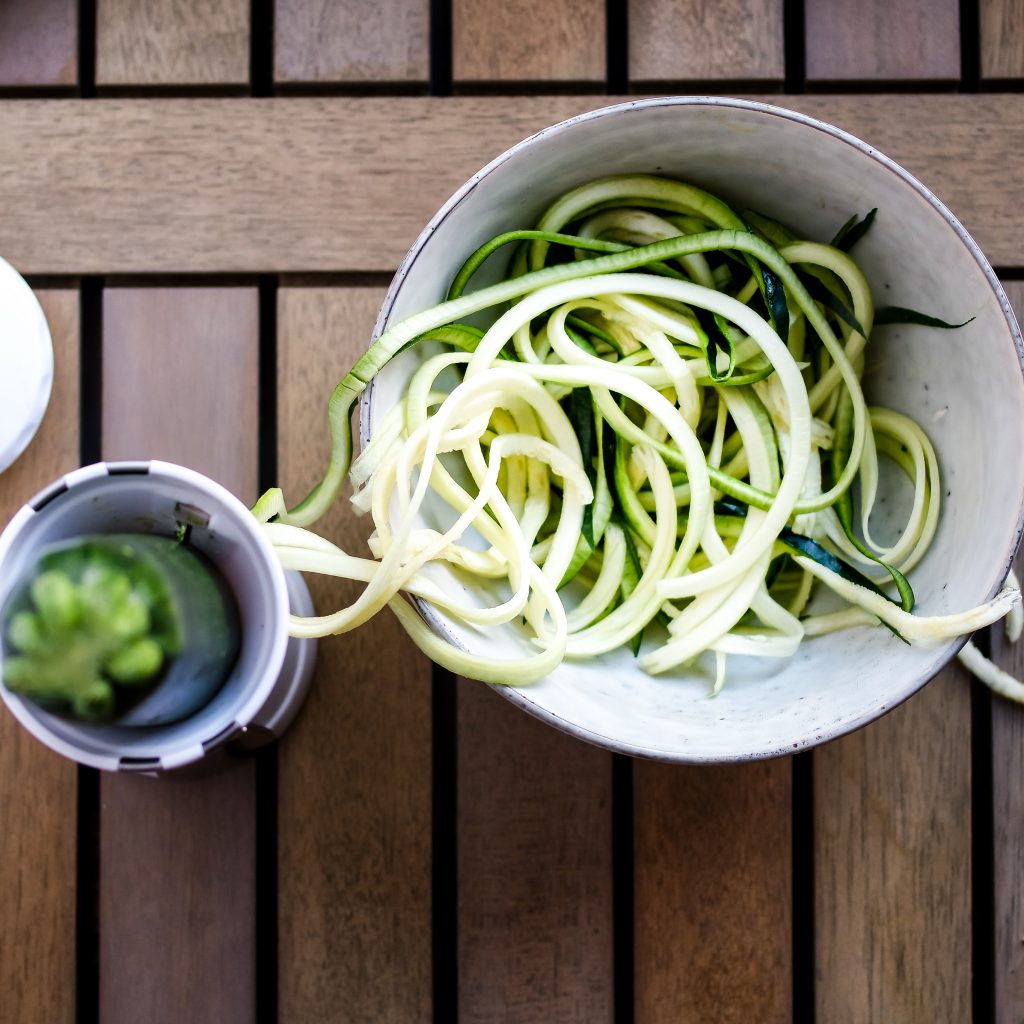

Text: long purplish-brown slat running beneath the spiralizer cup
xmin=99 ymin=288 xmax=258 ymax=1024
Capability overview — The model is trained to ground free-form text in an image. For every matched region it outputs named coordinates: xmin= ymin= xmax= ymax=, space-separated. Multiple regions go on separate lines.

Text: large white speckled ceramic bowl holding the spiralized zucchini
xmin=361 ymin=97 xmax=1024 ymax=762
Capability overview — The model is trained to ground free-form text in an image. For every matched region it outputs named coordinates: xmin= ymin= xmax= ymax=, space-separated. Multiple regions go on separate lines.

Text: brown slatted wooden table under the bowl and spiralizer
xmin=0 ymin=0 xmax=1024 ymax=1024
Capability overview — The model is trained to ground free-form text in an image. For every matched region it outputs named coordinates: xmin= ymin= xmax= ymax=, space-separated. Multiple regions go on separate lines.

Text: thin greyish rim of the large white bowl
xmin=359 ymin=95 xmax=1024 ymax=764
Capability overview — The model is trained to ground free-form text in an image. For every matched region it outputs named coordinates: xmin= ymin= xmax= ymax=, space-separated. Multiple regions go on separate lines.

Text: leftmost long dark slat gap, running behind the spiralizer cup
xmin=75 ymin=278 xmax=103 ymax=1024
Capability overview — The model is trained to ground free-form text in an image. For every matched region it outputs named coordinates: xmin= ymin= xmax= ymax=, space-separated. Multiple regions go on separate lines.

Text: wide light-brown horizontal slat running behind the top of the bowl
xmin=0 ymin=94 xmax=1024 ymax=273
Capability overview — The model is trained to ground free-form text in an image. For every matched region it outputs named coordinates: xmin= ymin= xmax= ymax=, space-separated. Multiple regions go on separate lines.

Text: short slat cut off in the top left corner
xmin=0 ymin=0 xmax=78 ymax=85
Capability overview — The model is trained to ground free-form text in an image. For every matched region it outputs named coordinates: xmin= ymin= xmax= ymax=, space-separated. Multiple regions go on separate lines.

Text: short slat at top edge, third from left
xmin=273 ymin=0 xmax=430 ymax=82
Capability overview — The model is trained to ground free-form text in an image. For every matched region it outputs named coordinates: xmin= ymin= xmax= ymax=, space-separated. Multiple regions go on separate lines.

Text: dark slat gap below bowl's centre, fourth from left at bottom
xmin=611 ymin=754 xmax=636 ymax=1024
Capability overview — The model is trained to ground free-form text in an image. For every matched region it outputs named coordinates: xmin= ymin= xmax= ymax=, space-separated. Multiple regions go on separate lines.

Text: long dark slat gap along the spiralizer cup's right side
xmin=254 ymin=274 xmax=279 ymax=1024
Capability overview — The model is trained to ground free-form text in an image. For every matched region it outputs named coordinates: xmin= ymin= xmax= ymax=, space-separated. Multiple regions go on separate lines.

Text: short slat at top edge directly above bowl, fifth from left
xmin=629 ymin=0 xmax=782 ymax=82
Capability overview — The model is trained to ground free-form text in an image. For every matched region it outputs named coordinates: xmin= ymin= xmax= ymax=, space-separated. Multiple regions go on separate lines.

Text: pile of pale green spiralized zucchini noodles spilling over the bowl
xmin=253 ymin=175 xmax=1020 ymax=692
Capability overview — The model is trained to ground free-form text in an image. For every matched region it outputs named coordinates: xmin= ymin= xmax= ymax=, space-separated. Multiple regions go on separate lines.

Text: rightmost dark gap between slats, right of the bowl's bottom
xmin=971 ymin=623 xmax=1002 ymax=1021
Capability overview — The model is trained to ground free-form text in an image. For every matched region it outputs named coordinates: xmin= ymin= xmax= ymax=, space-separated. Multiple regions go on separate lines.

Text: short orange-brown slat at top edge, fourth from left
xmin=452 ymin=0 xmax=606 ymax=82
